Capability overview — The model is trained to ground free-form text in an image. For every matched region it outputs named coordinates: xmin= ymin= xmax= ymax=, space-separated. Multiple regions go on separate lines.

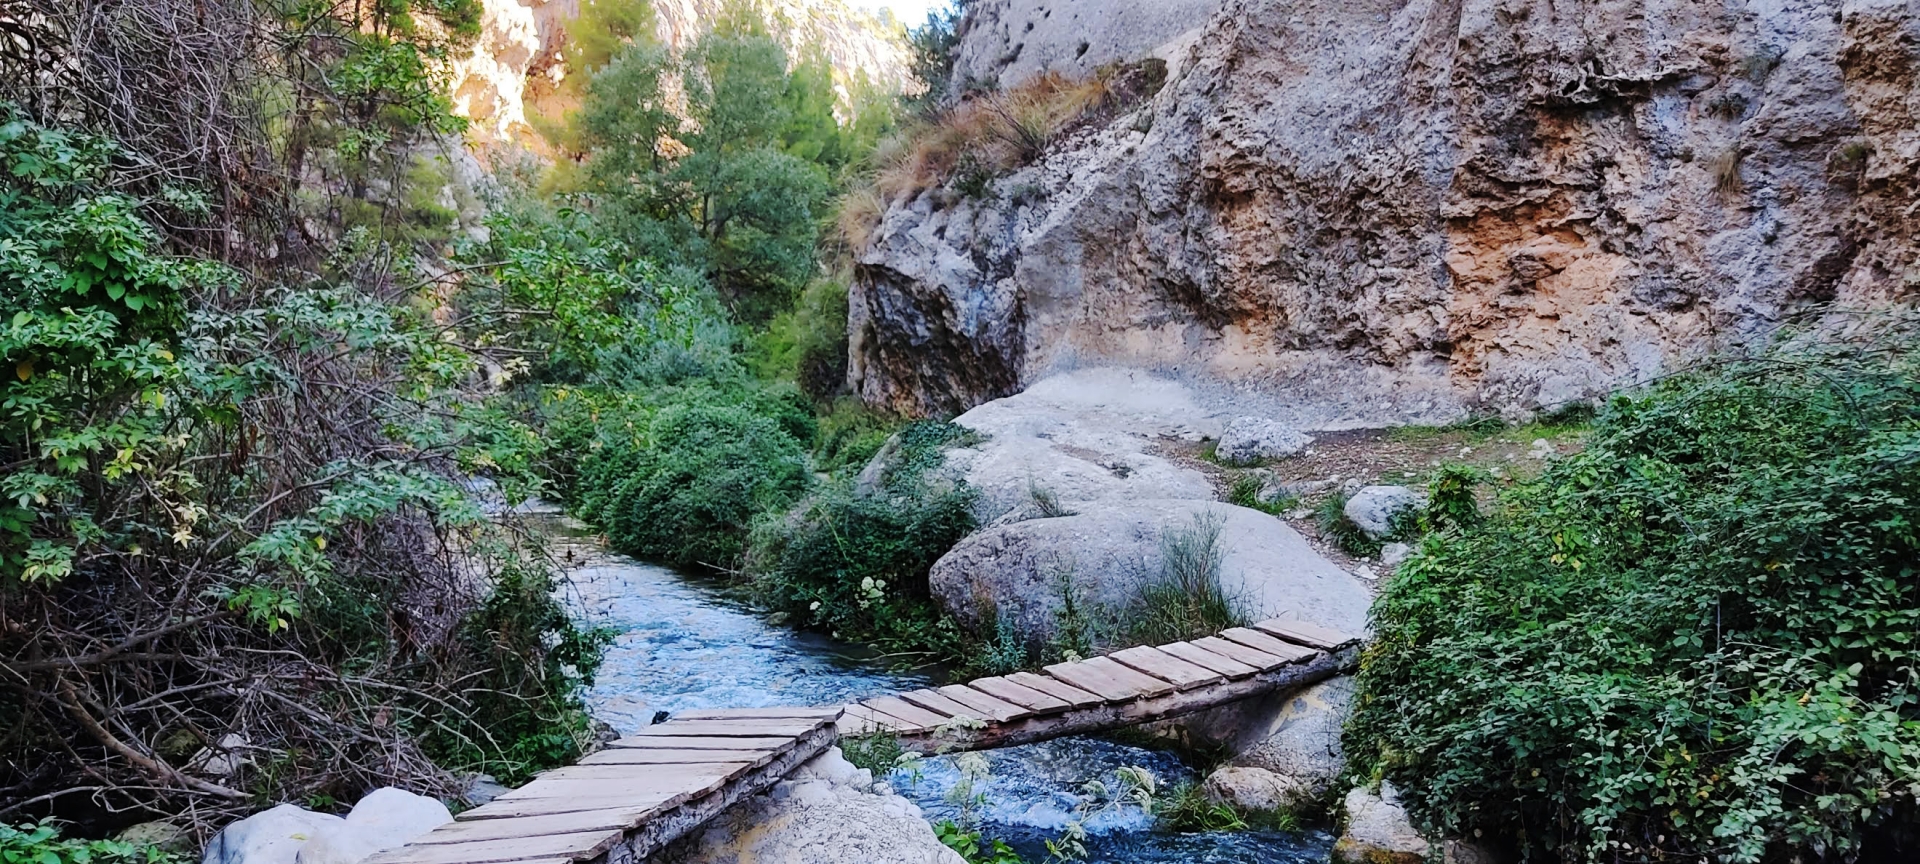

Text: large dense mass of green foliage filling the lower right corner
xmin=1346 ymin=342 xmax=1920 ymax=862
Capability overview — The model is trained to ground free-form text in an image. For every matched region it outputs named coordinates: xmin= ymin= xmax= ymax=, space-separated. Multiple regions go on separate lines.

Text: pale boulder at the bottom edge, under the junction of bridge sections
xmin=657 ymin=749 xmax=966 ymax=864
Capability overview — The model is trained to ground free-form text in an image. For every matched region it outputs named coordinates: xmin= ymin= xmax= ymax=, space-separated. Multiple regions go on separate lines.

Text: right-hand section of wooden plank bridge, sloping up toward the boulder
xmin=839 ymin=620 xmax=1359 ymax=753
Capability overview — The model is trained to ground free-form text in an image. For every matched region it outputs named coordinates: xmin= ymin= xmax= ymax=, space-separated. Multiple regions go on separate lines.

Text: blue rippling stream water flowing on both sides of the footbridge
xmin=570 ymin=545 xmax=1332 ymax=864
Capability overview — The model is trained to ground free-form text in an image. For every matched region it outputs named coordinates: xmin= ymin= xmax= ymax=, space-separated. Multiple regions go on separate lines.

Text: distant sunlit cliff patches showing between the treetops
xmin=447 ymin=0 xmax=912 ymax=150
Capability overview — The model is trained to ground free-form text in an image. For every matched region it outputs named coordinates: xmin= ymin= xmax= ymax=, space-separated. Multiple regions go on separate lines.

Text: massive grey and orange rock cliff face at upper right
xmin=851 ymin=0 xmax=1920 ymax=428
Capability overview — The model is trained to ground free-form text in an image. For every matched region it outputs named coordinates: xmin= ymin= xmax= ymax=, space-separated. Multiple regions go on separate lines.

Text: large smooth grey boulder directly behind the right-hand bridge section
xmin=927 ymin=499 xmax=1371 ymax=643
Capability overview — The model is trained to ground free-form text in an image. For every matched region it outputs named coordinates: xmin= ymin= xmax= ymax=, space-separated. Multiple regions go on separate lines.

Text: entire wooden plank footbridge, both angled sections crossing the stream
xmin=369 ymin=620 xmax=1359 ymax=864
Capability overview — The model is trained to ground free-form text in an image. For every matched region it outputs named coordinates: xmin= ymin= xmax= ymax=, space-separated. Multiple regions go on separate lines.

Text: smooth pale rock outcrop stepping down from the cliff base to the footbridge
xmin=906 ymin=369 xmax=1371 ymax=645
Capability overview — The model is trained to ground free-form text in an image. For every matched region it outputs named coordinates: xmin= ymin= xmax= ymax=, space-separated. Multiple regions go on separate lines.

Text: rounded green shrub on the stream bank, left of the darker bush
xmin=574 ymin=388 xmax=812 ymax=568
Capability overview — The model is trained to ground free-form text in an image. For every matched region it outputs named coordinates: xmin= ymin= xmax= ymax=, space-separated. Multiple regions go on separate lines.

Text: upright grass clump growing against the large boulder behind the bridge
xmin=1129 ymin=516 xmax=1246 ymax=645
